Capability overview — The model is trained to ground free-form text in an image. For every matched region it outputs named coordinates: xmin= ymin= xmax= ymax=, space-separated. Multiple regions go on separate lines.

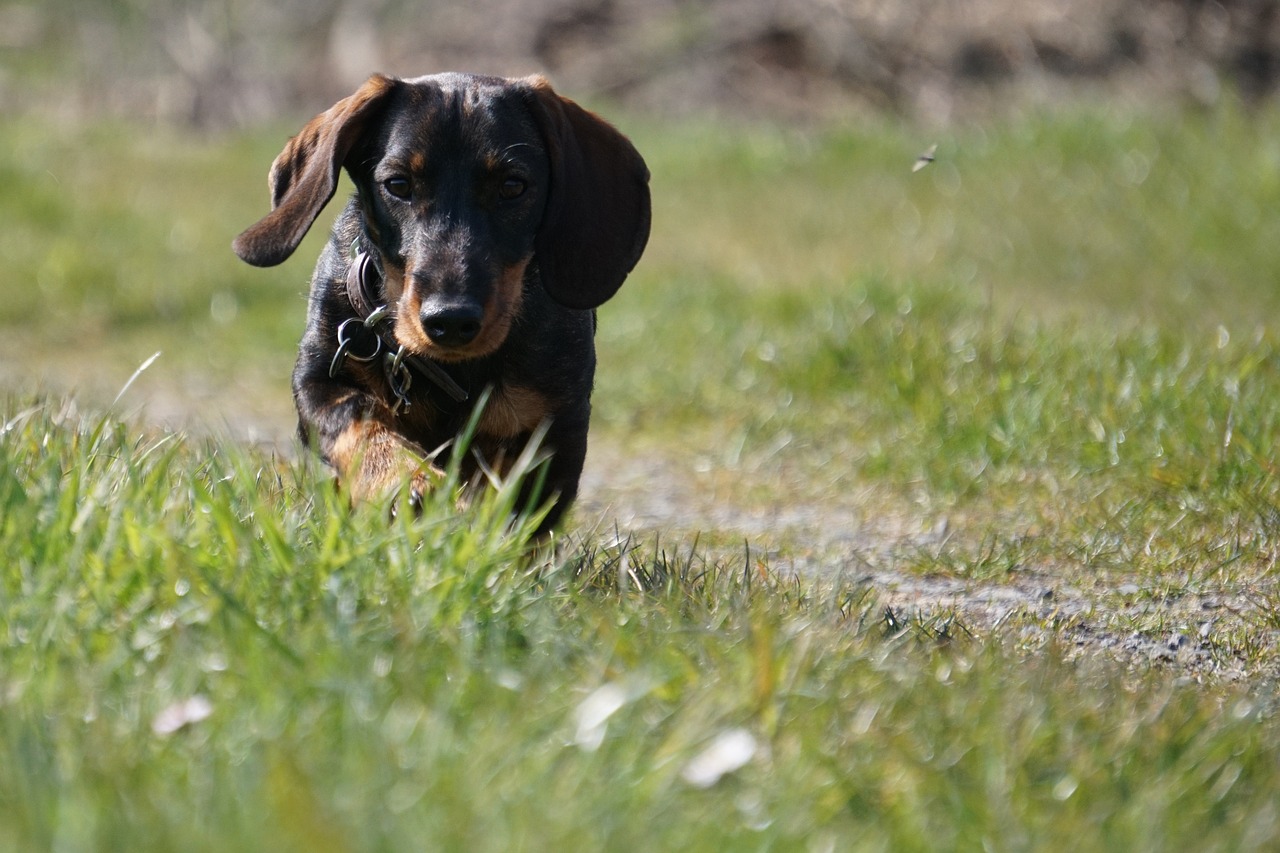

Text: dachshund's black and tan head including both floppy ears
xmin=234 ymin=74 xmax=650 ymax=361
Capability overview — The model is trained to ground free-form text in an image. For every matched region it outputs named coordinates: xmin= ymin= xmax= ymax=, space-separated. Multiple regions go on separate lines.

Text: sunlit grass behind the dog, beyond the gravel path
xmin=0 ymin=105 xmax=1280 ymax=578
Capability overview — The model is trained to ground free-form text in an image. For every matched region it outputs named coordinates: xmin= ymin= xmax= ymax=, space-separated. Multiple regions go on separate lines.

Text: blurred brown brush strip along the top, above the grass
xmin=10 ymin=0 xmax=1280 ymax=127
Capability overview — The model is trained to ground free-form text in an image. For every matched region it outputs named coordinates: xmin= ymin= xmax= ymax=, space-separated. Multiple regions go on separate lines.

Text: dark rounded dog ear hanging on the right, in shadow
xmin=527 ymin=77 xmax=649 ymax=309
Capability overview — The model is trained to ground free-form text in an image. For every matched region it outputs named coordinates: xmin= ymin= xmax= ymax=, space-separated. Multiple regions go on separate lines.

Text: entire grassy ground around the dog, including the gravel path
xmin=0 ymin=97 xmax=1280 ymax=850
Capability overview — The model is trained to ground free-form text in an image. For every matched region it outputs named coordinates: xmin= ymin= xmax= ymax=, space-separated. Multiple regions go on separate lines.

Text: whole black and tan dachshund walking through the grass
xmin=234 ymin=74 xmax=649 ymax=529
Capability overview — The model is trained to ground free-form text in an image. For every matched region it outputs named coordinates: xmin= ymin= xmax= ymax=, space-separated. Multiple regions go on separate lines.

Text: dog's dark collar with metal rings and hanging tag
xmin=329 ymin=245 xmax=470 ymax=412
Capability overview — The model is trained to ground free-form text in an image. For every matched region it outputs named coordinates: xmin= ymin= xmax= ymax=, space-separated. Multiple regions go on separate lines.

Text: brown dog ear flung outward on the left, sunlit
xmin=232 ymin=74 xmax=397 ymax=266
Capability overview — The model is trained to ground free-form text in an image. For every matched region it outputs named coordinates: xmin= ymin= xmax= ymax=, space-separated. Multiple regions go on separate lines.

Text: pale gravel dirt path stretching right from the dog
xmin=577 ymin=441 xmax=1280 ymax=680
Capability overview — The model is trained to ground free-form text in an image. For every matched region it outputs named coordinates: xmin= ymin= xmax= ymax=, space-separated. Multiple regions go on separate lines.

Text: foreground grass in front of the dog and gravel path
xmin=0 ymin=406 xmax=1280 ymax=850
